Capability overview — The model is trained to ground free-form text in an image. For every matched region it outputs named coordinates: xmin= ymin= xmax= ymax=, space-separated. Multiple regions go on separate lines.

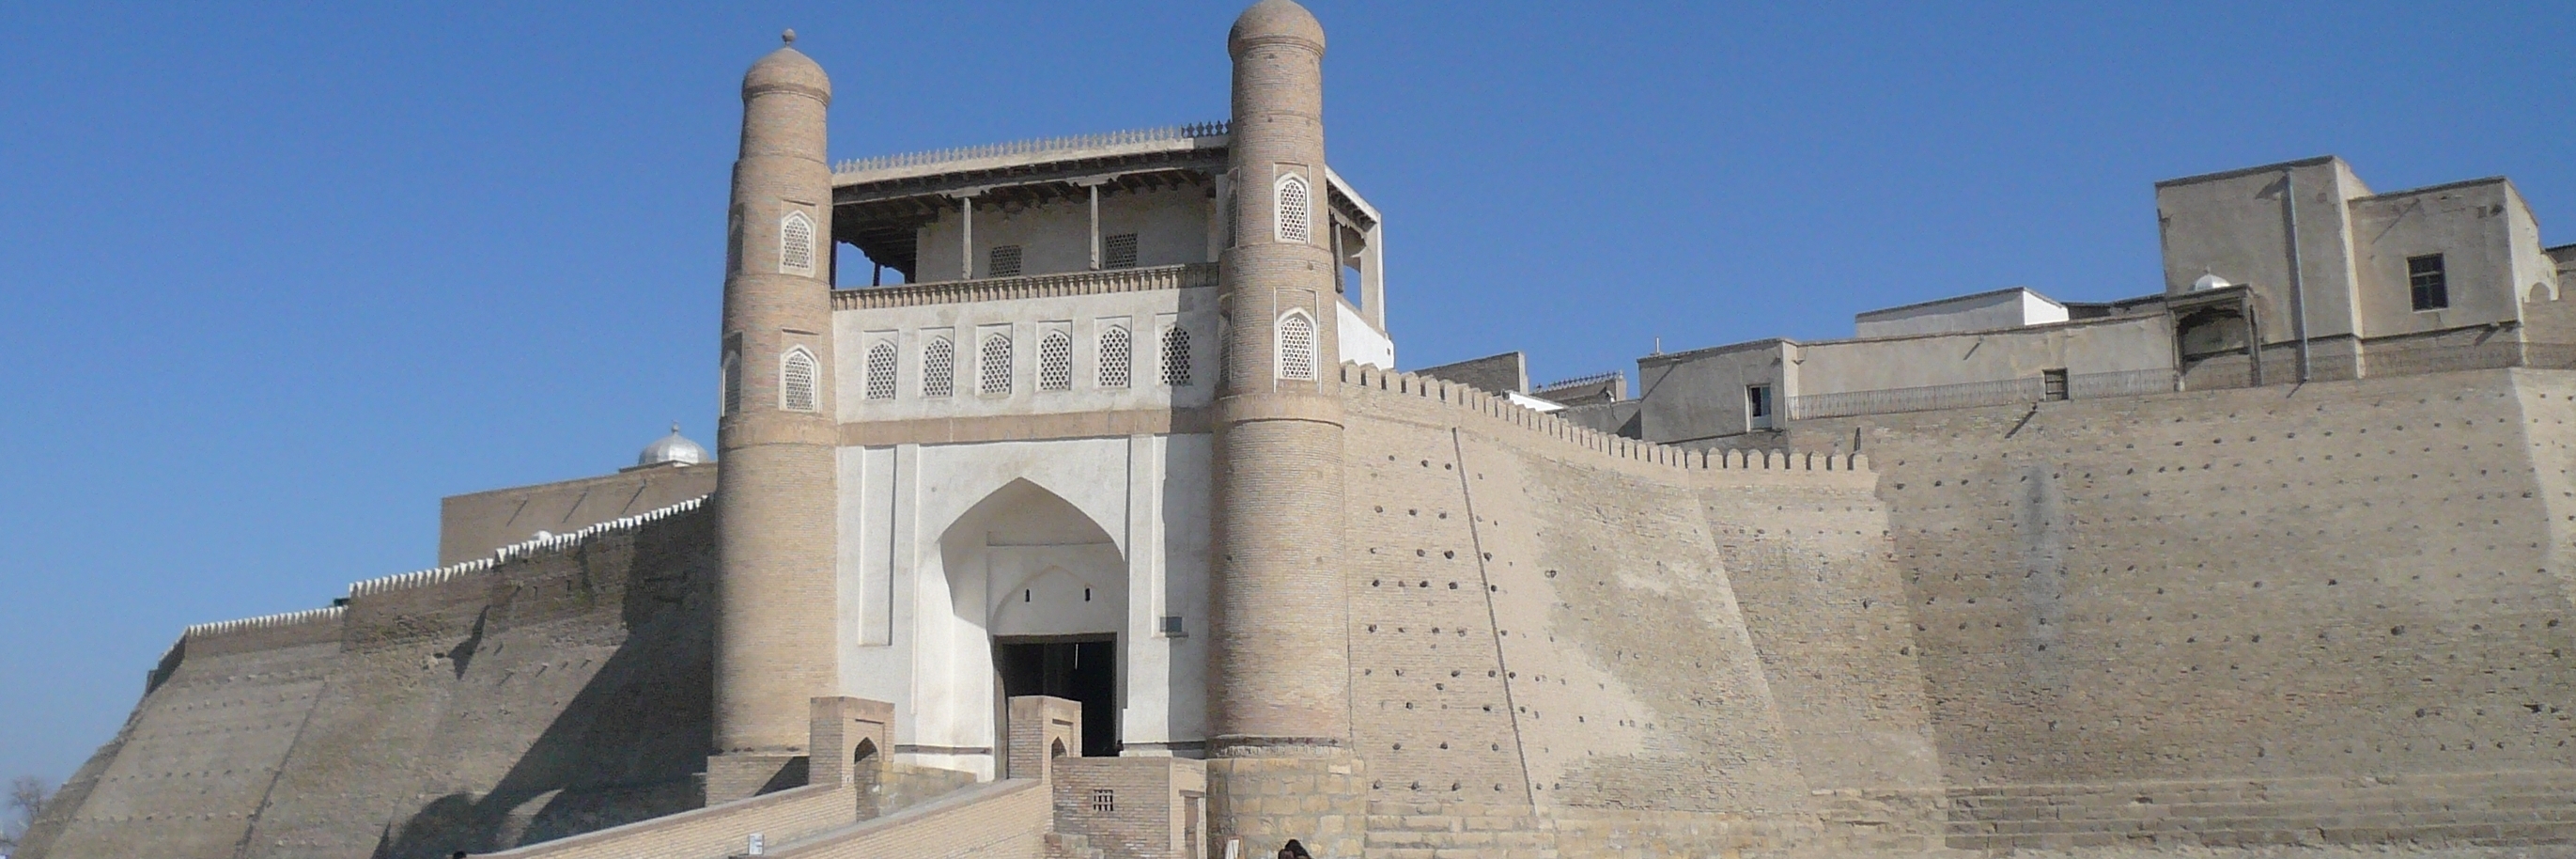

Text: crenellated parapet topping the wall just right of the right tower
xmin=1342 ymin=364 xmax=1878 ymax=480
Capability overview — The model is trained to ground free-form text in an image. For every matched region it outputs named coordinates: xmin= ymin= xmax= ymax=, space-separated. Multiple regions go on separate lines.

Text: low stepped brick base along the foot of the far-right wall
xmin=1948 ymin=772 xmax=2576 ymax=849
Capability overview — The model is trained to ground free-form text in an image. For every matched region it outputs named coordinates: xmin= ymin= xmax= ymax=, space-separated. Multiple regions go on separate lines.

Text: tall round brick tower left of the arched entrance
xmin=706 ymin=31 xmax=840 ymax=803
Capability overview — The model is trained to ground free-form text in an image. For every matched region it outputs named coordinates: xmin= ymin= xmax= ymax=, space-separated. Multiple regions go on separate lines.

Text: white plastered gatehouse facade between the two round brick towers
xmin=834 ymin=287 xmax=1218 ymax=779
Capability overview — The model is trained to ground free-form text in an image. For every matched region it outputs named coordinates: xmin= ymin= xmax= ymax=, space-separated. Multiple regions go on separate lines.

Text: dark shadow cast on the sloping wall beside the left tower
xmin=374 ymin=519 xmax=714 ymax=859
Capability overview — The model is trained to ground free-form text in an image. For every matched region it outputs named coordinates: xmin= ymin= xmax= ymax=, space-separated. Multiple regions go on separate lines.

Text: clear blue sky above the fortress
xmin=0 ymin=0 xmax=2576 ymax=779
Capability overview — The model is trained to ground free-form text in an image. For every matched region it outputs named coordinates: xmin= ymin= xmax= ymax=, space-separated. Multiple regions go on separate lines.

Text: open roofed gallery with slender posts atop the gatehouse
xmin=832 ymin=121 xmax=1386 ymax=336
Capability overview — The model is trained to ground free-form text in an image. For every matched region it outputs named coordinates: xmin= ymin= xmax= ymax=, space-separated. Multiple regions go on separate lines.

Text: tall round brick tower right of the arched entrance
xmin=1208 ymin=0 xmax=1365 ymax=856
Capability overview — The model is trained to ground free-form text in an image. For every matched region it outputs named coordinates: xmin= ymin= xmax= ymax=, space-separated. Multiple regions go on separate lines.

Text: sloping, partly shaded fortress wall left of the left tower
xmin=23 ymin=500 xmax=714 ymax=859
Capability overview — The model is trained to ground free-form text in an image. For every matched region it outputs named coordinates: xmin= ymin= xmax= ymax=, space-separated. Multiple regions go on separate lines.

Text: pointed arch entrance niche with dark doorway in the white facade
xmin=940 ymin=480 xmax=1128 ymax=761
